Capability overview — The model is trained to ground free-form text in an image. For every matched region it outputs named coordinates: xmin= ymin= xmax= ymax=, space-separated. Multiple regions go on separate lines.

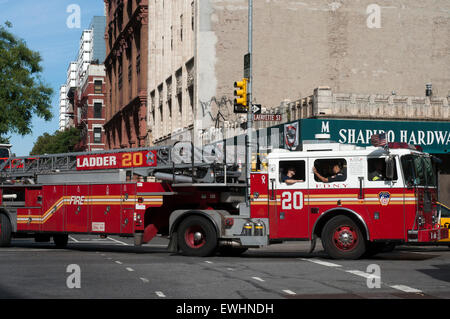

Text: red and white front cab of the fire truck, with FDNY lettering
xmin=241 ymin=141 xmax=445 ymax=259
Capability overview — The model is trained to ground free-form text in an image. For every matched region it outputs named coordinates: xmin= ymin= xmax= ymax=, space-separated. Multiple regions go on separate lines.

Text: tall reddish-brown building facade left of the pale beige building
xmin=104 ymin=0 xmax=148 ymax=149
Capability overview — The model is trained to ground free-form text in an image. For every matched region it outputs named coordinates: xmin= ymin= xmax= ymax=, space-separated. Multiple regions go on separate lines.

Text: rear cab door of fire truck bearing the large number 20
xmin=269 ymin=159 xmax=309 ymax=239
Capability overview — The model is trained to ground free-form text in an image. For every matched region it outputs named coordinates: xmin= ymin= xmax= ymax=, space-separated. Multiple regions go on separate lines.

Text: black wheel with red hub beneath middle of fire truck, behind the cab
xmin=177 ymin=216 xmax=217 ymax=257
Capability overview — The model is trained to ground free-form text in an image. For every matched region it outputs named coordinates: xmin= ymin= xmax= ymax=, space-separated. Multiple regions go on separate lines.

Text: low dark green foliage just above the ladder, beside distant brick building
xmin=30 ymin=128 xmax=81 ymax=155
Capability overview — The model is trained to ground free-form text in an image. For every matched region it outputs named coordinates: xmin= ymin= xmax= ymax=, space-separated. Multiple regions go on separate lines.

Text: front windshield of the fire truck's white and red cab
xmin=402 ymin=155 xmax=436 ymax=186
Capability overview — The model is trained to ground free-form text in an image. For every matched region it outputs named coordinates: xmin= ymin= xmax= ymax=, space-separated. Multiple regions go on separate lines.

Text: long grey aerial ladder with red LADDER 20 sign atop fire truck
xmin=0 ymin=142 xmax=245 ymax=186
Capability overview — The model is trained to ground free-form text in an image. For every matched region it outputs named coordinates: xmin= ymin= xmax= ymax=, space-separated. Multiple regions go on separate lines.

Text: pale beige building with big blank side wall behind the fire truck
xmin=147 ymin=0 xmax=450 ymax=145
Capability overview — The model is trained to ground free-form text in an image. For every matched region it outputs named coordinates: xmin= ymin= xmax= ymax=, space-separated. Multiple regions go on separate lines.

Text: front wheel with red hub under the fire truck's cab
xmin=321 ymin=215 xmax=366 ymax=259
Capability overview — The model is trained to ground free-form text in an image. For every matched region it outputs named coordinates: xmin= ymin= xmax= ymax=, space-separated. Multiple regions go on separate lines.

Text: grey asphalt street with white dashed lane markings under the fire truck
xmin=0 ymin=235 xmax=450 ymax=300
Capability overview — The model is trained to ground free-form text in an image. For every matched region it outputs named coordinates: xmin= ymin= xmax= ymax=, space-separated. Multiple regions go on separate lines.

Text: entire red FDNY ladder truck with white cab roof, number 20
xmin=0 ymin=141 xmax=448 ymax=259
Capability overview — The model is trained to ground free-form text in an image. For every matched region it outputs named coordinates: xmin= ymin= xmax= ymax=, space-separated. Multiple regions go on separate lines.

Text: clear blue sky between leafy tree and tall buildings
xmin=0 ymin=0 xmax=104 ymax=156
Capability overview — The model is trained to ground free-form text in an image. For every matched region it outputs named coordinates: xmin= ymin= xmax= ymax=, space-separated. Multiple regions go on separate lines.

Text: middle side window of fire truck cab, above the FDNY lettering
xmin=313 ymin=159 xmax=347 ymax=183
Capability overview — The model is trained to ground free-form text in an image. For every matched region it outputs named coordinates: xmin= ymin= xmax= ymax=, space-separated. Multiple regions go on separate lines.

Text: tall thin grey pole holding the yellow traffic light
xmin=246 ymin=0 xmax=253 ymax=209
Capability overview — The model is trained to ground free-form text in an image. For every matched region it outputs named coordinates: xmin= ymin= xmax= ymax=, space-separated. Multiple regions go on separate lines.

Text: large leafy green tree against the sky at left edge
xmin=0 ymin=22 xmax=53 ymax=142
